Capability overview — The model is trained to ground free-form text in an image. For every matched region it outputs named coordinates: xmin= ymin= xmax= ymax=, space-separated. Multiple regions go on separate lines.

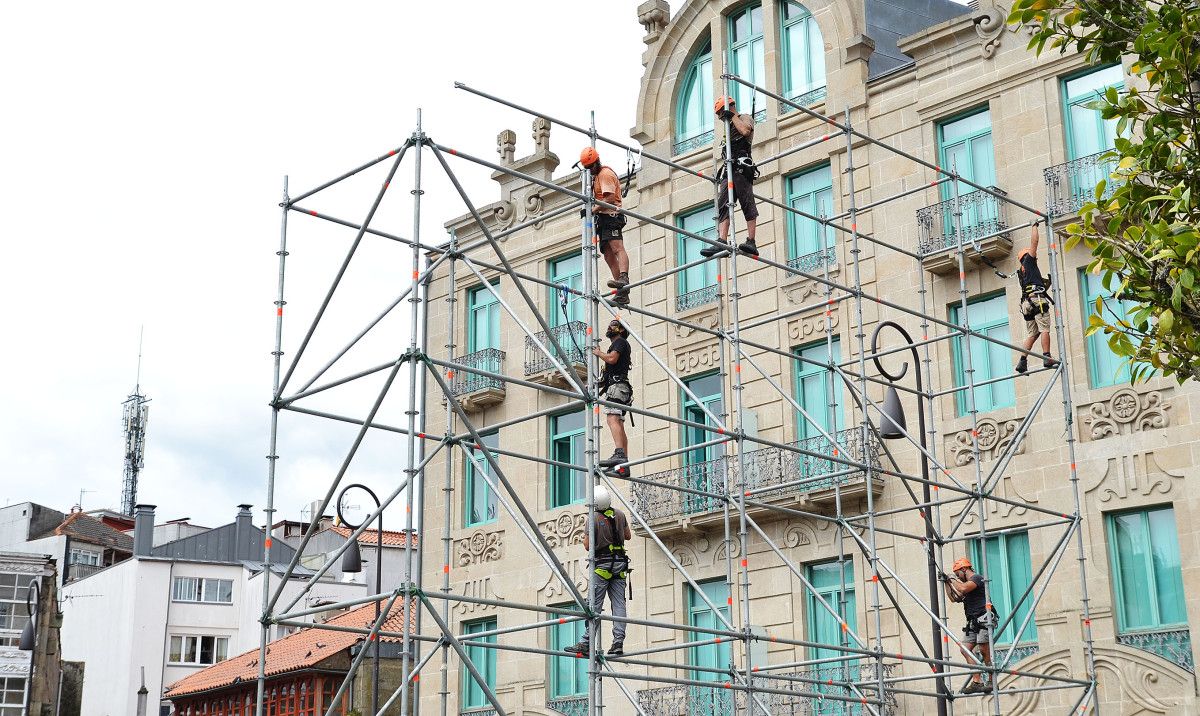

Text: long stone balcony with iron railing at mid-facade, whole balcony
xmin=634 ymin=428 xmax=883 ymax=533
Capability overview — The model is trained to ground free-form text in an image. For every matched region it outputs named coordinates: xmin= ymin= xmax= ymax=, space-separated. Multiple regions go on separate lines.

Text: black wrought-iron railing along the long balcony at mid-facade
xmin=634 ymin=428 xmax=881 ymax=522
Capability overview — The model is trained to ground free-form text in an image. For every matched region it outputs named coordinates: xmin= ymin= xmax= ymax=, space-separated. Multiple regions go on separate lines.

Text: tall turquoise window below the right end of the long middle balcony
xmin=804 ymin=560 xmax=858 ymax=715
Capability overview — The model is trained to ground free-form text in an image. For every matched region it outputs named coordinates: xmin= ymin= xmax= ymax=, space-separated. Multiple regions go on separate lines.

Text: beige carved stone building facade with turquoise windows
xmin=420 ymin=0 xmax=1200 ymax=716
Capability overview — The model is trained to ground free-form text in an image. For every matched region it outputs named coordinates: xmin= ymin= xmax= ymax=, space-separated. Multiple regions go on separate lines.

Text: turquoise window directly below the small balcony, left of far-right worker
xmin=950 ymin=294 xmax=1016 ymax=415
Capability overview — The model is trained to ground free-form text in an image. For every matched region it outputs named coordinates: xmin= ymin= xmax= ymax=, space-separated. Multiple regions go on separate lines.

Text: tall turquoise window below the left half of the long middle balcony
xmin=688 ymin=580 xmax=734 ymax=716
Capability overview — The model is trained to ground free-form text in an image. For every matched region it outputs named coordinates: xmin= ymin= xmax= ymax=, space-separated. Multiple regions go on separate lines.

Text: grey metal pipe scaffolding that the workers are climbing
xmin=257 ymin=68 xmax=1098 ymax=716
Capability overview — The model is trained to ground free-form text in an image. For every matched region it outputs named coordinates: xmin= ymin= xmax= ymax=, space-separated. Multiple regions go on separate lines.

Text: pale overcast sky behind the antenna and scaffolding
xmin=0 ymin=0 xmax=652 ymax=525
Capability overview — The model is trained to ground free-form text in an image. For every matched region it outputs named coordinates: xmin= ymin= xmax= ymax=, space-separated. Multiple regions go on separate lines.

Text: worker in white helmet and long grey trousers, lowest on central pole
xmin=566 ymin=486 xmax=634 ymax=656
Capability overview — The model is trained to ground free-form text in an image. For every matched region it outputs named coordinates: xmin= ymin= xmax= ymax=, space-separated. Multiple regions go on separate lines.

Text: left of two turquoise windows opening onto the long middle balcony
xmin=683 ymin=373 xmax=725 ymax=512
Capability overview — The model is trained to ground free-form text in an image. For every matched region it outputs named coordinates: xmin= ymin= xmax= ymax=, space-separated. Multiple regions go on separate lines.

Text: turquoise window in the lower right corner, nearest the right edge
xmin=1104 ymin=505 xmax=1188 ymax=634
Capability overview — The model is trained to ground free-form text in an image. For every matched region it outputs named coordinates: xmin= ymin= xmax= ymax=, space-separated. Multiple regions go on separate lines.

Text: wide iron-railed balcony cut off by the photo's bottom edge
xmin=637 ymin=662 xmax=898 ymax=716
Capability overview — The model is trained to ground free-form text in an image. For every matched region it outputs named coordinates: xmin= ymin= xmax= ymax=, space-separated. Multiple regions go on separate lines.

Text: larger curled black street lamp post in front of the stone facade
xmin=871 ymin=320 xmax=947 ymax=716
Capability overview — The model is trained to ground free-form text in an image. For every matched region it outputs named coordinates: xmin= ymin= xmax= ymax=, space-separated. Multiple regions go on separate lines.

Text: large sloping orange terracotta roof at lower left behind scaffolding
xmin=164 ymin=601 xmax=419 ymax=698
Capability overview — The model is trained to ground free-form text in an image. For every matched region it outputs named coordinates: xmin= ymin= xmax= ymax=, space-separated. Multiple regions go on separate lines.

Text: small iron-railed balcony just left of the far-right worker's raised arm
xmin=917 ymin=187 xmax=1013 ymax=273
